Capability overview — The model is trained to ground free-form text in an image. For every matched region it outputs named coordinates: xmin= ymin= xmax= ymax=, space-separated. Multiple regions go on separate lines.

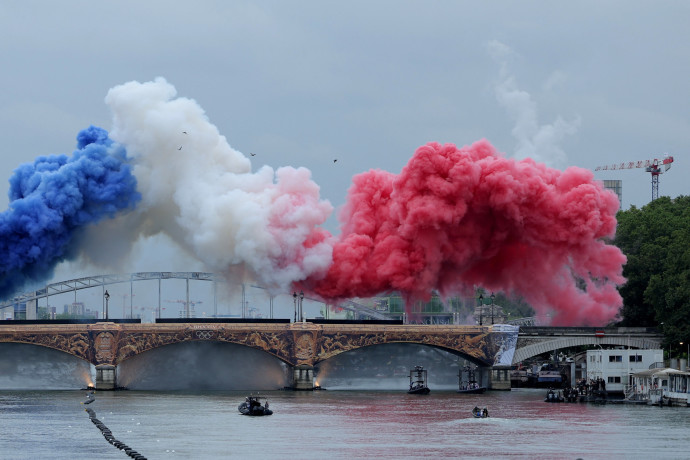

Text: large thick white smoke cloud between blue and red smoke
xmin=79 ymin=78 xmax=332 ymax=289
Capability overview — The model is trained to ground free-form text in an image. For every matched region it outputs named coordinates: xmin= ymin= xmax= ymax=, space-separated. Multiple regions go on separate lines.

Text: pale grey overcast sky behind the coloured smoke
xmin=0 ymin=1 xmax=690 ymax=320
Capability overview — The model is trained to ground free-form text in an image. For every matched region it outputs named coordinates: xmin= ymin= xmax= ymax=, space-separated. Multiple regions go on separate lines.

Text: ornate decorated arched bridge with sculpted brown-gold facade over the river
xmin=0 ymin=322 xmax=517 ymax=389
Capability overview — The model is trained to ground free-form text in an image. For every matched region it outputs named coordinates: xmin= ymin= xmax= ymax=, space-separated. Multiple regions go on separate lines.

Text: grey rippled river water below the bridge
xmin=0 ymin=389 xmax=690 ymax=459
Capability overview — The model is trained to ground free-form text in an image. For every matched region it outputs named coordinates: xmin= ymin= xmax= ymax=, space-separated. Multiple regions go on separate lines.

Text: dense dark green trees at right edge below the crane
xmin=615 ymin=196 xmax=690 ymax=343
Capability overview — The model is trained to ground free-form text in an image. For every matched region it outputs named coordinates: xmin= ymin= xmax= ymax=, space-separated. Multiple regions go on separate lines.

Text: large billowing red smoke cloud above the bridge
xmin=304 ymin=141 xmax=626 ymax=325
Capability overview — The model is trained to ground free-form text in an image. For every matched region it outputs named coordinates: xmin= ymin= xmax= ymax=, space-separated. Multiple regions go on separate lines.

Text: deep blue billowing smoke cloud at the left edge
xmin=0 ymin=126 xmax=141 ymax=298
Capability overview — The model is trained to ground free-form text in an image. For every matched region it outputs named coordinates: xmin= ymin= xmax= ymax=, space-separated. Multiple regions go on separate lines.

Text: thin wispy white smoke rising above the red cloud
xmin=487 ymin=40 xmax=580 ymax=169
